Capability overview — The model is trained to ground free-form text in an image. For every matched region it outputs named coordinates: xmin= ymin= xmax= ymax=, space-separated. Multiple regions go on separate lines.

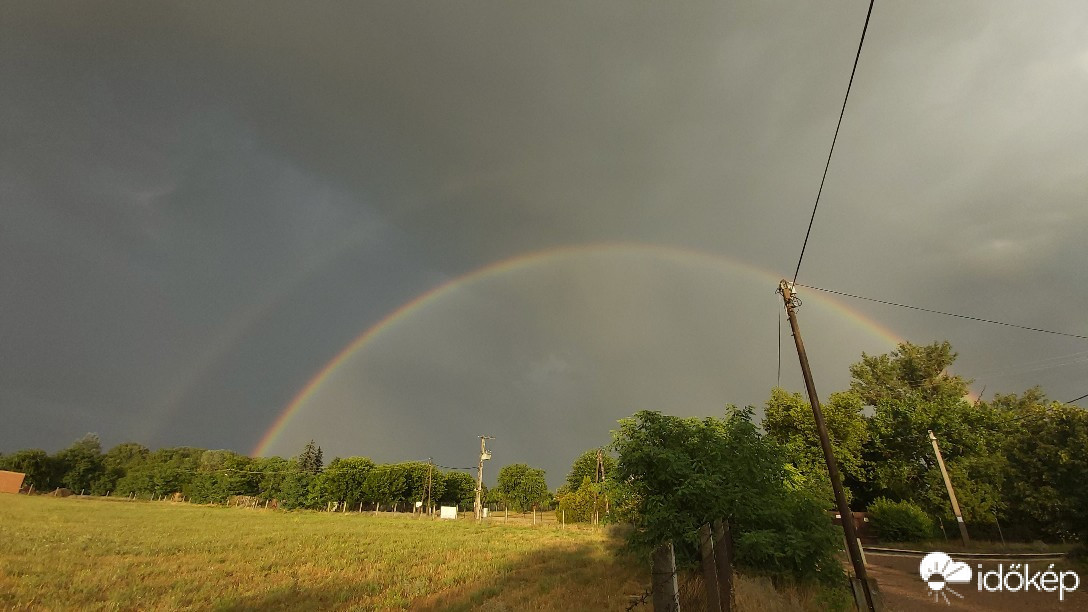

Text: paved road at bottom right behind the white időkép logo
xmin=865 ymin=551 xmax=1088 ymax=612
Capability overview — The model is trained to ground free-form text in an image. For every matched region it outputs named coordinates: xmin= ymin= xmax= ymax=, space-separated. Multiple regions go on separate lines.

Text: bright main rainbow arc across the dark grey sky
xmin=250 ymin=243 xmax=902 ymax=456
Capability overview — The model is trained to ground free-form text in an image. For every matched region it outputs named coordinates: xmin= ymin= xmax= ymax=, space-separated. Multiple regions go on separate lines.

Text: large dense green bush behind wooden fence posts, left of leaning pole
xmin=613 ymin=408 xmax=842 ymax=582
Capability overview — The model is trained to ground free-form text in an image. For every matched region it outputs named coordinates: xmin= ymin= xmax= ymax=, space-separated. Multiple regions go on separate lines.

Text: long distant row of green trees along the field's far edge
xmin=0 ymin=433 xmax=570 ymax=512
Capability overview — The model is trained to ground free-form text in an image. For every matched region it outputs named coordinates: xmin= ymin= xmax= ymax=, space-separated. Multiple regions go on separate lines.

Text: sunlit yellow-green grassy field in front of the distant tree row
xmin=0 ymin=494 xmax=831 ymax=610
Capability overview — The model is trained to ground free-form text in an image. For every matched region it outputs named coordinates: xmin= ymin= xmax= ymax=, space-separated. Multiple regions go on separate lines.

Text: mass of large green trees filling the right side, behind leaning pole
xmin=557 ymin=342 xmax=1088 ymax=584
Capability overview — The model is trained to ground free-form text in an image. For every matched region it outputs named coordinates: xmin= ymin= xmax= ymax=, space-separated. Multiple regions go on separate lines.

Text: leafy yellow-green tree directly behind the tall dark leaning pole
xmin=763 ymin=388 xmax=868 ymax=509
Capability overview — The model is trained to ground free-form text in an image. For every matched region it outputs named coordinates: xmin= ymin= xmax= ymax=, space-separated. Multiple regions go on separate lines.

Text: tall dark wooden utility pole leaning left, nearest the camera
xmin=778 ymin=279 xmax=876 ymax=612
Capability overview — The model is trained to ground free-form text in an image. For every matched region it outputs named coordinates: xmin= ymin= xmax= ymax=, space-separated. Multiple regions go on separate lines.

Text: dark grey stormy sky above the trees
xmin=0 ymin=1 xmax=1088 ymax=487
